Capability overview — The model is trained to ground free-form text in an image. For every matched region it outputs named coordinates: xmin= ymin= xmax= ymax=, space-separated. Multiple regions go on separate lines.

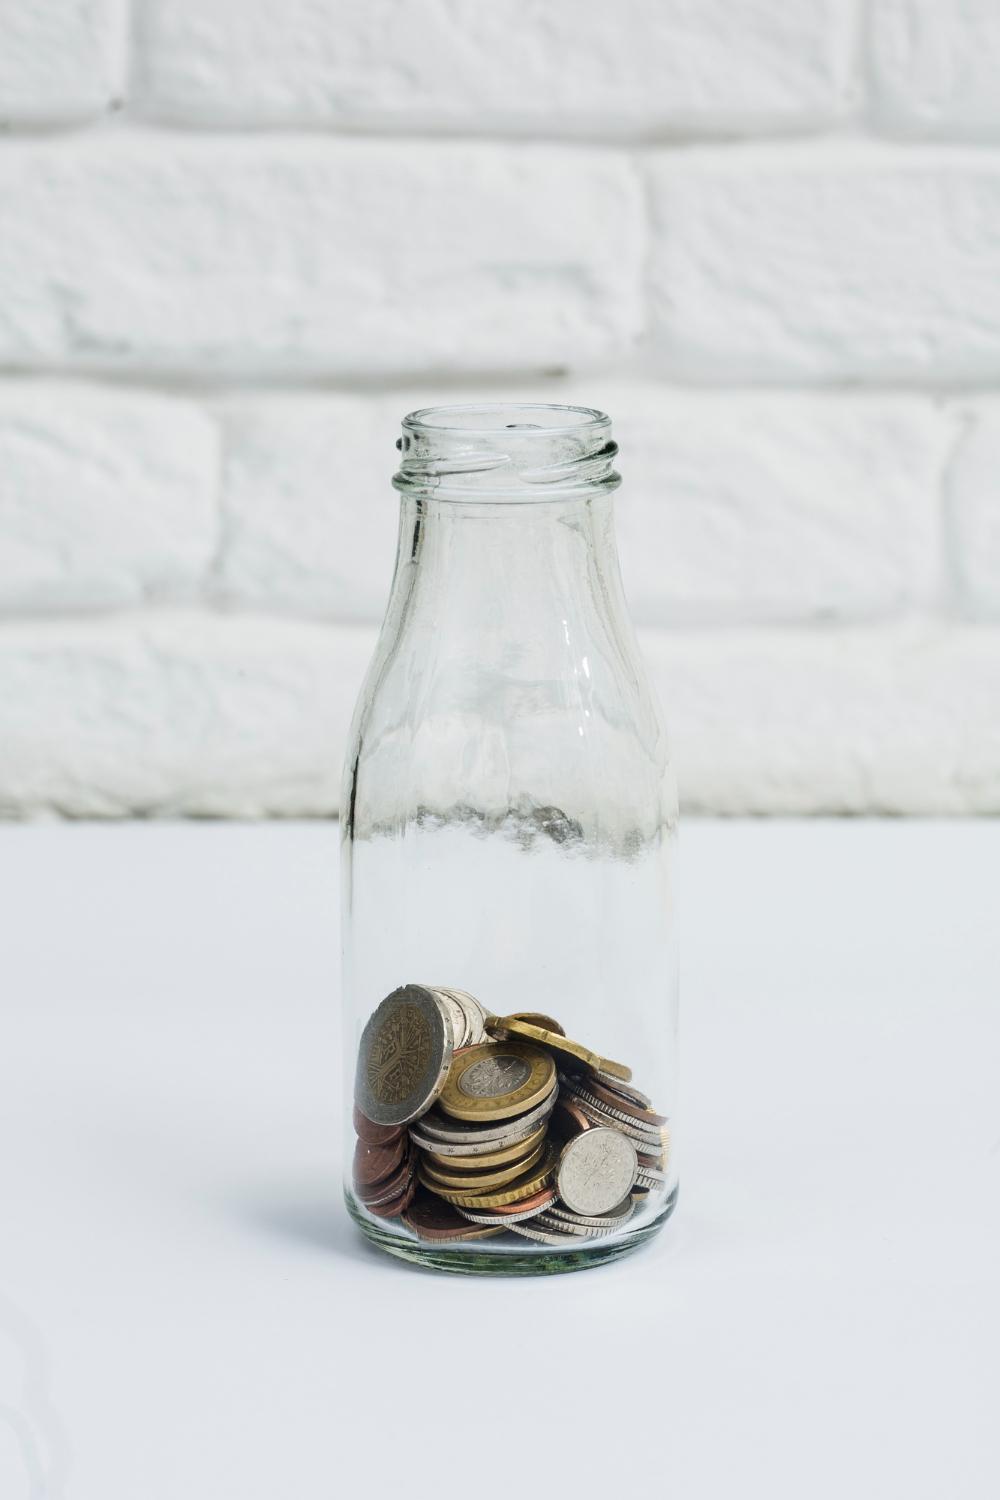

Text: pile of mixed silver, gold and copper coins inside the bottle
xmin=354 ymin=984 xmax=669 ymax=1247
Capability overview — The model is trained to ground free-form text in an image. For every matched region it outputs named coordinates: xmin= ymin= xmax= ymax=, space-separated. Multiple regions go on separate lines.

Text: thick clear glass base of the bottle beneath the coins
xmin=343 ymin=1184 xmax=678 ymax=1277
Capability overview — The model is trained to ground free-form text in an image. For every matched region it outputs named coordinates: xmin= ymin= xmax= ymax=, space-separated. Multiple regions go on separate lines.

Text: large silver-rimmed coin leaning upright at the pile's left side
xmin=354 ymin=984 xmax=454 ymax=1125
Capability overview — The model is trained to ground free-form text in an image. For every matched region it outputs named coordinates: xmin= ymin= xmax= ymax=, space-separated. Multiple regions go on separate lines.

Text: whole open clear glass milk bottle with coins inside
xmin=342 ymin=405 xmax=676 ymax=1274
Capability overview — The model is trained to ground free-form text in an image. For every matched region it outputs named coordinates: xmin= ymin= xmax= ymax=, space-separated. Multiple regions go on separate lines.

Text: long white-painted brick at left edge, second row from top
xmin=0 ymin=134 xmax=642 ymax=380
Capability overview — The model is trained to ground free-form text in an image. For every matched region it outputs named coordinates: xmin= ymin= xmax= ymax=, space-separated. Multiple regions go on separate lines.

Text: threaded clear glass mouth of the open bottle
xmin=393 ymin=402 xmax=621 ymax=504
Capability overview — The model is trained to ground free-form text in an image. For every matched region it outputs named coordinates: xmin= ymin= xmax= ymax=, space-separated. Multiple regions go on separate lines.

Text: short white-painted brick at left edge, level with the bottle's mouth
xmin=0 ymin=381 xmax=219 ymax=611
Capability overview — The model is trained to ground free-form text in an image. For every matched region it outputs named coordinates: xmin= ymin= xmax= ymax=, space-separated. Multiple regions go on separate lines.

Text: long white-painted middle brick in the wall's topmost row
xmin=136 ymin=0 xmax=853 ymax=135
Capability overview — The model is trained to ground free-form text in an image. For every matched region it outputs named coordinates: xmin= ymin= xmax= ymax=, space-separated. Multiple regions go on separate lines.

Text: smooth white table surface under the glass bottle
xmin=0 ymin=822 xmax=1000 ymax=1500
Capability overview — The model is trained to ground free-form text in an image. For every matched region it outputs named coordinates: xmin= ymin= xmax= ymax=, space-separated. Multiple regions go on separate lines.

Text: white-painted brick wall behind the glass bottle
xmin=0 ymin=0 xmax=1000 ymax=816
